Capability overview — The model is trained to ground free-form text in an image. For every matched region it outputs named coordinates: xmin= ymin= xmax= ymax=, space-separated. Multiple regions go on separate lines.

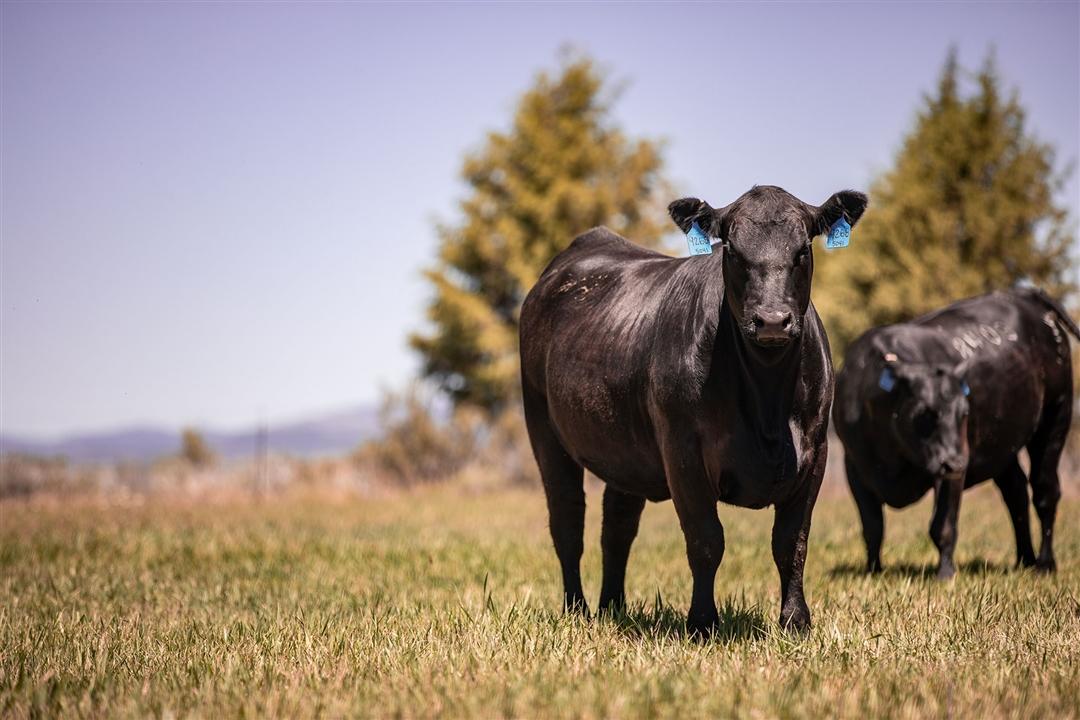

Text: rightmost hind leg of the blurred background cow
xmin=1027 ymin=384 xmax=1072 ymax=572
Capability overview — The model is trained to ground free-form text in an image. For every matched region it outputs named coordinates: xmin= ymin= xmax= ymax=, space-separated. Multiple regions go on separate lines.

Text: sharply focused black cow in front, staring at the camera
xmin=521 ymin=187 xmax=866 ymax=634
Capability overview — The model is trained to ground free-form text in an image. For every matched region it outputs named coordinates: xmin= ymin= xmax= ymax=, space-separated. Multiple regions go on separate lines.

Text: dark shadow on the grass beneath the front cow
xmin=599 ymin=596 xmax=769 ymax=643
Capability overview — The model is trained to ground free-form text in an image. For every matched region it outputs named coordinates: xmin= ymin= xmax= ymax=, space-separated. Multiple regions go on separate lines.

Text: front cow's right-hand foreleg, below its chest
xmin=772 ymin=451 xmax=828 ymax=633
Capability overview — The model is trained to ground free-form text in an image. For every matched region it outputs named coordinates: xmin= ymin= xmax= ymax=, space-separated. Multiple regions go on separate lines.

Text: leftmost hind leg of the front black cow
xmin=524 ymin=392 xmax=589 ymax=615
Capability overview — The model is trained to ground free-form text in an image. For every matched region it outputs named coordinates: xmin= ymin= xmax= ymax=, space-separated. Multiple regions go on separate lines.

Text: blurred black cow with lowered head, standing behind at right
xmin=833 ymin=288 xmax=1080 ymax=579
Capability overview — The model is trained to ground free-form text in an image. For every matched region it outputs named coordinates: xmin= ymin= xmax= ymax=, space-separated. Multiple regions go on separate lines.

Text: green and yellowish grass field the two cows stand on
xmin=0 ymin=487 xmax=1080 ymax=718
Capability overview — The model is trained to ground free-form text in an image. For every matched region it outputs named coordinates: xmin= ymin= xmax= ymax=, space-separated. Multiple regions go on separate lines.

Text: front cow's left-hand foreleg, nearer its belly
xmin=664 ymin=433 xmax=724 ymax=638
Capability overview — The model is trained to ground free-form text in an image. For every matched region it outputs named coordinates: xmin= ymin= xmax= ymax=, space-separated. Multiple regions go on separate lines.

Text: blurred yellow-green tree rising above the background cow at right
xmin=814 ymin=51 xmax=1072 ymax=357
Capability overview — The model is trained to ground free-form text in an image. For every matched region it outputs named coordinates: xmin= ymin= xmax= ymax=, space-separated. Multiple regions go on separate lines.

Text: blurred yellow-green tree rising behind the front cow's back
xmin=409 ymin=58 xmax=667 ymax=411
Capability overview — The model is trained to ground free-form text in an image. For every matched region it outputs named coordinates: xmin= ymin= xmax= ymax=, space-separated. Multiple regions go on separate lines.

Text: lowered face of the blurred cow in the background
xmin=877 ymin=362 xmax=970 ymax=478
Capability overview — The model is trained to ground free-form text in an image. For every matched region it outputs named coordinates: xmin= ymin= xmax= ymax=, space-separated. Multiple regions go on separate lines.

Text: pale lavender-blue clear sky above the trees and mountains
xmin=0 ymin=1 xmax=1080 ymax=438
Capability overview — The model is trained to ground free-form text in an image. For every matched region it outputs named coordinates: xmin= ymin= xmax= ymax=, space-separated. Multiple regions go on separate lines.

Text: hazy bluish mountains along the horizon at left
xmin=0 ymin=406 xmax=378 ymax=462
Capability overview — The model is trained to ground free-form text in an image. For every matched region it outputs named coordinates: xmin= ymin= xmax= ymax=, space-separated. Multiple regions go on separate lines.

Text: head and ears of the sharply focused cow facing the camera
xmin=667 ymin=186 xmax=866 ymax=348
